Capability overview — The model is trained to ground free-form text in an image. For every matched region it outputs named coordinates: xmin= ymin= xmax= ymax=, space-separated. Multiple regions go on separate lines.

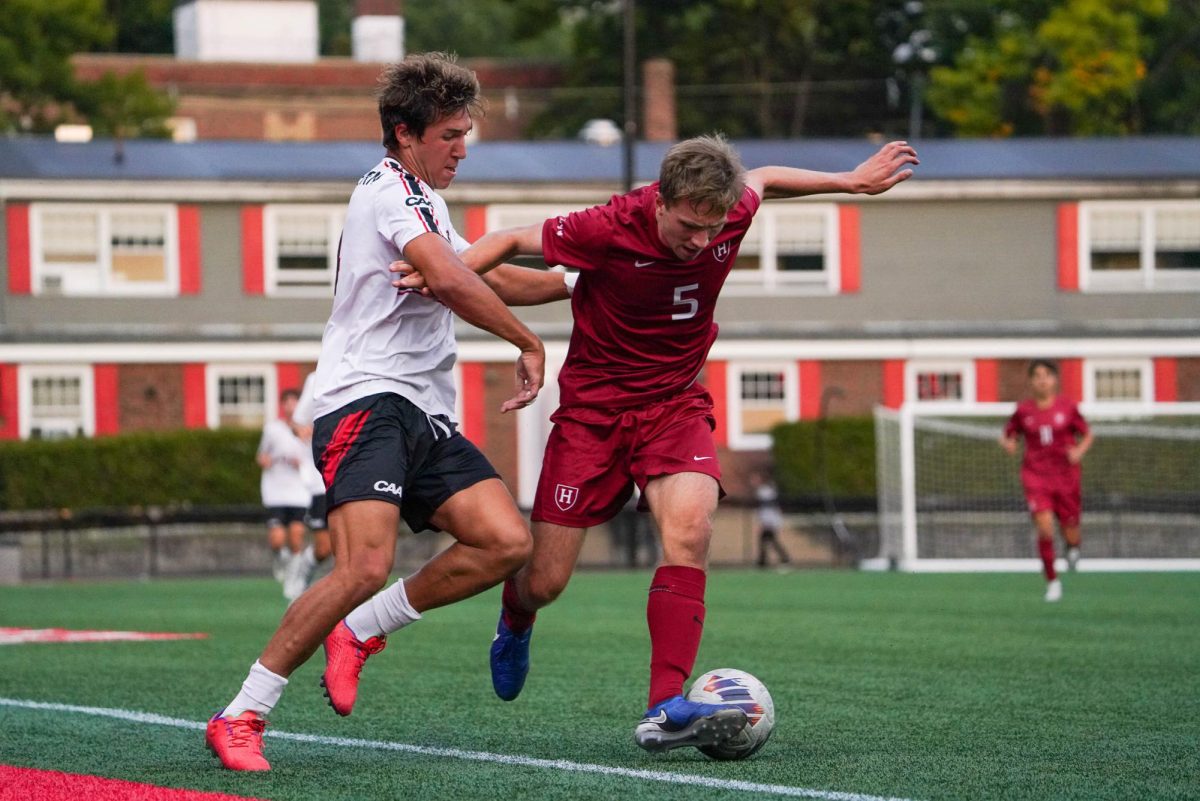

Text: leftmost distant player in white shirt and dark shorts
xmin=254 ymin=387 xmax=311 ymax=600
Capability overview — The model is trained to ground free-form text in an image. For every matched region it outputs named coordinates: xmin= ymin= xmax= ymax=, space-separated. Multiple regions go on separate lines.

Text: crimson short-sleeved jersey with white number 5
xmin=541 ymin=183 xmax=761 ymax=409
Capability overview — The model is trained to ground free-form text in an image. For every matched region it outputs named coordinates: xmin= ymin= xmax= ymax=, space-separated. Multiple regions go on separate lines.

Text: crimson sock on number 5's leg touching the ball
xmin=646 ymin=565 xmax=706 ymax=706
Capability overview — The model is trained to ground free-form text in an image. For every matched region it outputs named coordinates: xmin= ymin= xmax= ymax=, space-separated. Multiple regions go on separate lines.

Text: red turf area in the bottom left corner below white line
xmin=0 ymin=765 xmax=264 ymax=801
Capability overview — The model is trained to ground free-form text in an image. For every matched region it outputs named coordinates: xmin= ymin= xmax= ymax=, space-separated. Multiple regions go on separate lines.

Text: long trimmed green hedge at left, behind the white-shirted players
xmin=0 ymin=429 xmax=262 ymax=510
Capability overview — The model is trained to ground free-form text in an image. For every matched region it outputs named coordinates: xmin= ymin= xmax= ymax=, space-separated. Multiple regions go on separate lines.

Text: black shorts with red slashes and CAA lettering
xmin=312 ymin=392 xmax=499 ymax=531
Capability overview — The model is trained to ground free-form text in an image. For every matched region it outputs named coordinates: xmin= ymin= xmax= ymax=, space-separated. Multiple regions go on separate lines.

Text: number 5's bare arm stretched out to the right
xmin=746 ymin=141 xmax=920 ymax=200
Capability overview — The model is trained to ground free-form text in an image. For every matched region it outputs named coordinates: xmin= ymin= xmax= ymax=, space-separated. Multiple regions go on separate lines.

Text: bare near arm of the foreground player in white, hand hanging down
xmin=404 ymin=227 xmax=546 ymax=411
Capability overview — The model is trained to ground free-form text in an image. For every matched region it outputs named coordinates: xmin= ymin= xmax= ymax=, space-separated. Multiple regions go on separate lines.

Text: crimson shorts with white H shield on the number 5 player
xmin=532 ymin=385 xmax=721 ymax=529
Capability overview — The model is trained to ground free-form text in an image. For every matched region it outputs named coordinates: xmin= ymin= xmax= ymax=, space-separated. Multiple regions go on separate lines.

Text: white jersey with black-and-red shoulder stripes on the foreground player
xmin=313 ymin=153 xmax=469 ymax=420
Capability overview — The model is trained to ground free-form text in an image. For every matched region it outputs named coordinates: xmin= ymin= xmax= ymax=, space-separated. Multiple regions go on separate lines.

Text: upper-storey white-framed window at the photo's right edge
xmin=1080 ymin=201 xmax=1200 ymax=291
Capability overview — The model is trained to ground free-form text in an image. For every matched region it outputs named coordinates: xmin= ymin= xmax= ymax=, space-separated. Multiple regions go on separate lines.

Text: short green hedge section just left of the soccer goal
xmin=772 ymin=417 xmax=875 ymax=498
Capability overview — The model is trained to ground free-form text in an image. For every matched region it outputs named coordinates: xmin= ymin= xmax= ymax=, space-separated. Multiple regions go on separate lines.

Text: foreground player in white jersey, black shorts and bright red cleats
xmin=206 ymin=53 xmax=545 ymax=771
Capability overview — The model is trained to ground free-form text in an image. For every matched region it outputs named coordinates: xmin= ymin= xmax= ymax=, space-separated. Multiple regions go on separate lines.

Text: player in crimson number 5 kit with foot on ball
xmin=394 ymin=131 xmax=917 ymax=751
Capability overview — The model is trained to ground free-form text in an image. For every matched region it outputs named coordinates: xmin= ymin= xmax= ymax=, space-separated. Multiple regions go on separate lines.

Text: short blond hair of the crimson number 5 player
xmin=659 ymin=133 xmax=745 ymax=213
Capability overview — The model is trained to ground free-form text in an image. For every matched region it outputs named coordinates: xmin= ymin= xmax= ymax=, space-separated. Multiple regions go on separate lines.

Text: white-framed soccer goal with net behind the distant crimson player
xmin=863 ymin=403 xmax=1200 ymax=571
